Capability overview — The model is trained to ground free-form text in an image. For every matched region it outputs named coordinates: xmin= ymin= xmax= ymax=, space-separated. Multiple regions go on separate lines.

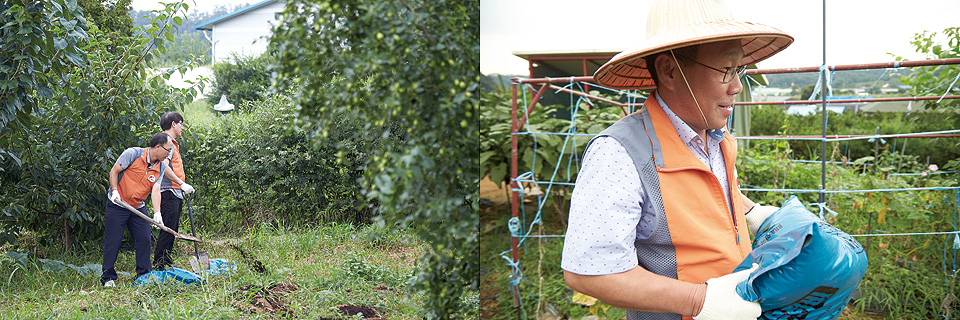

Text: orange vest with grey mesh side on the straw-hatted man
xmin=585 ymin=94 xmax=751 ymax=319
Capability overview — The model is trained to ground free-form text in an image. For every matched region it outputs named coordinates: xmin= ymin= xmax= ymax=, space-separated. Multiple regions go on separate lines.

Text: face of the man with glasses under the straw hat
xmin=677 ymin=40 xmax=743 ymax=131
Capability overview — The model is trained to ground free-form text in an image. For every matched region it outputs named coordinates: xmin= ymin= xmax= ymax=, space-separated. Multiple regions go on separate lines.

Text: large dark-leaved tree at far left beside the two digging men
xmin=0 ymin=0 xmax=199 ymax=250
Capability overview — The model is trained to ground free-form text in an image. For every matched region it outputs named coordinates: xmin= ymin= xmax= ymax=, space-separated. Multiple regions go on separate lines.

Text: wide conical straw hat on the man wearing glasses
xmin=593 ymin=0 xmax=793 ymax=89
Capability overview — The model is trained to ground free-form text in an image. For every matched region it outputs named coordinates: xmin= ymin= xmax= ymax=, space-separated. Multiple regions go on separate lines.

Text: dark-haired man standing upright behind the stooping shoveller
xmin=151 ymin=112 xmax=186 ymax=270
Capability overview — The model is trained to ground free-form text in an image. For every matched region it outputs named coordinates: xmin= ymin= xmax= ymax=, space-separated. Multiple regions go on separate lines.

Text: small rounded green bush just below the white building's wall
xmin=206 ymin=52 xmax=276 ymax=107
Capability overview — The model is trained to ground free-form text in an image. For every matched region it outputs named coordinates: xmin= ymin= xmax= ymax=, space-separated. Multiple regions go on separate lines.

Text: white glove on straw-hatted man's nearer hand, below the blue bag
xmin=693 ymin=263 xmax=763 ymax=320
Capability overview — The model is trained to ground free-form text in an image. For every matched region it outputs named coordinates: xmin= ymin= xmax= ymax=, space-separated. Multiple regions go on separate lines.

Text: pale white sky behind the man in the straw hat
xmin=480 ymin=0 xmax=960 ymax=75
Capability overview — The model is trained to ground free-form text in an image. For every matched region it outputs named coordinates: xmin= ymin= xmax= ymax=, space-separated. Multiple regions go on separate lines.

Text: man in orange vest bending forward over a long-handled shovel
xmin=100 ymin=132 xmax=193 ymax=287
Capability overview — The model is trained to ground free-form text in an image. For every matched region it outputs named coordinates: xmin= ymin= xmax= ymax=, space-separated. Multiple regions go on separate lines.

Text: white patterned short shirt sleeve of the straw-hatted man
xmin=560 ymin=137 xmax=650 ymax=275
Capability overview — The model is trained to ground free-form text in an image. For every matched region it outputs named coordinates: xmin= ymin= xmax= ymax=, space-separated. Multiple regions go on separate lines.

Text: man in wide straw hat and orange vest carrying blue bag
xmin=561 ymin=0 xmax=793 ymax=320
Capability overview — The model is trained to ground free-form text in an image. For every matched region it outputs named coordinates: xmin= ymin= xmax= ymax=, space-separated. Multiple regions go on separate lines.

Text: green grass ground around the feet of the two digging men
xmin=0 ymin=224 xmax=424 ymax=319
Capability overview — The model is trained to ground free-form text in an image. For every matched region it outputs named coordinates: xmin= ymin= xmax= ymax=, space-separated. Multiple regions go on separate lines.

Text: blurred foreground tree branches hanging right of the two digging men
xmin=271 ymin=0 xmax=480 ymax=318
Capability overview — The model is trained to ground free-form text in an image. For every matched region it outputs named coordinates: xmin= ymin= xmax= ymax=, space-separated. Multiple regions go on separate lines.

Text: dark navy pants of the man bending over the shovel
xmin=100 ymin=200 xmax=152 ymax=283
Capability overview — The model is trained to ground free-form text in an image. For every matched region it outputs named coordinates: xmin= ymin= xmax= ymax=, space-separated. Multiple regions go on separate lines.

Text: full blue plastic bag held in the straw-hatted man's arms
xmin=735 ymin=196 xmax=867 ymax=319
